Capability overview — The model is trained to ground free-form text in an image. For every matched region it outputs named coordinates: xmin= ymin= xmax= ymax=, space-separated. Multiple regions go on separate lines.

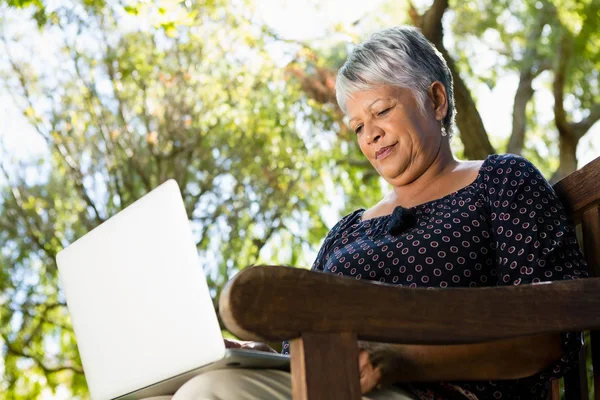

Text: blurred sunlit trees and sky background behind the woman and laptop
xmin=0 ymin=0 xmax=600 ymax=400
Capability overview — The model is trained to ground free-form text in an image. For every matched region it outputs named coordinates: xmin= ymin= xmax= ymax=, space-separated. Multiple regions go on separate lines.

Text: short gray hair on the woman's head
xmin=335 ymin=26 xmax=456 ymax=134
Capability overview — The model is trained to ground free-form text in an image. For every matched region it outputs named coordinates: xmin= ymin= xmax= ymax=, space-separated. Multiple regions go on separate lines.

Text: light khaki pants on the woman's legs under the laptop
xmin=144 ymin=369 xmax=416 ymax=400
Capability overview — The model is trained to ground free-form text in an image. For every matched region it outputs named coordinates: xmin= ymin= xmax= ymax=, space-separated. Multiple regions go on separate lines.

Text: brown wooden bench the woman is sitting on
xmin=220 ymin=158 xmax=600 ymax=400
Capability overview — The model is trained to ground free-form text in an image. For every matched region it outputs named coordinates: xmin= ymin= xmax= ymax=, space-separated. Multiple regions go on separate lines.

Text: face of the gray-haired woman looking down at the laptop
xmin=346 ymin=82 xmax=446 ymax=186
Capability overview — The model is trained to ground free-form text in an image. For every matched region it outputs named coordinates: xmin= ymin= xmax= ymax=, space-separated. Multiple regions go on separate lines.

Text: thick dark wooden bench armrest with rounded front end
xmin=220 ymin=266 xmax=600 ymax=344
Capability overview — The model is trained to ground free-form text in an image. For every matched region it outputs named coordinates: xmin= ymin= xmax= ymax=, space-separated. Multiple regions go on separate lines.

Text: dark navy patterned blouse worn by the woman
xmin=283 ymin=154 xmax=588 ymax=400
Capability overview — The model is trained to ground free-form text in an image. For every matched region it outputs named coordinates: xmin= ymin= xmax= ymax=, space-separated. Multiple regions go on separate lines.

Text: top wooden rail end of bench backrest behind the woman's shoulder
xmin=554 ymin=157 xmax=600 ymax=224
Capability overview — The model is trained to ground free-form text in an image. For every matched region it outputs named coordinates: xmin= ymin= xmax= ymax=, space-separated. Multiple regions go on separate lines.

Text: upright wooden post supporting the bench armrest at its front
xmin=290 ymin=333 xmax=361 ymax=400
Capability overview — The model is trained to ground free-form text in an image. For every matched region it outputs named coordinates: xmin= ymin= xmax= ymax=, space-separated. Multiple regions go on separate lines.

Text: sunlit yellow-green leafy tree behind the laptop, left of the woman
xmin=0 ymin=0 xmax=378 ymax=398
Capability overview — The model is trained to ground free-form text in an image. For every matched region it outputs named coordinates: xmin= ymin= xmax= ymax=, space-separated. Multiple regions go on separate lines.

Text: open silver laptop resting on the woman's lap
xmin=56 ymin=180 xmax=289 ymax=400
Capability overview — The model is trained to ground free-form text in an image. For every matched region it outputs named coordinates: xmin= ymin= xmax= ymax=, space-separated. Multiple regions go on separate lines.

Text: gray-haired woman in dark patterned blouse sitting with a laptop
xmin=148 ymin=27 xmax=587 ymax=400
